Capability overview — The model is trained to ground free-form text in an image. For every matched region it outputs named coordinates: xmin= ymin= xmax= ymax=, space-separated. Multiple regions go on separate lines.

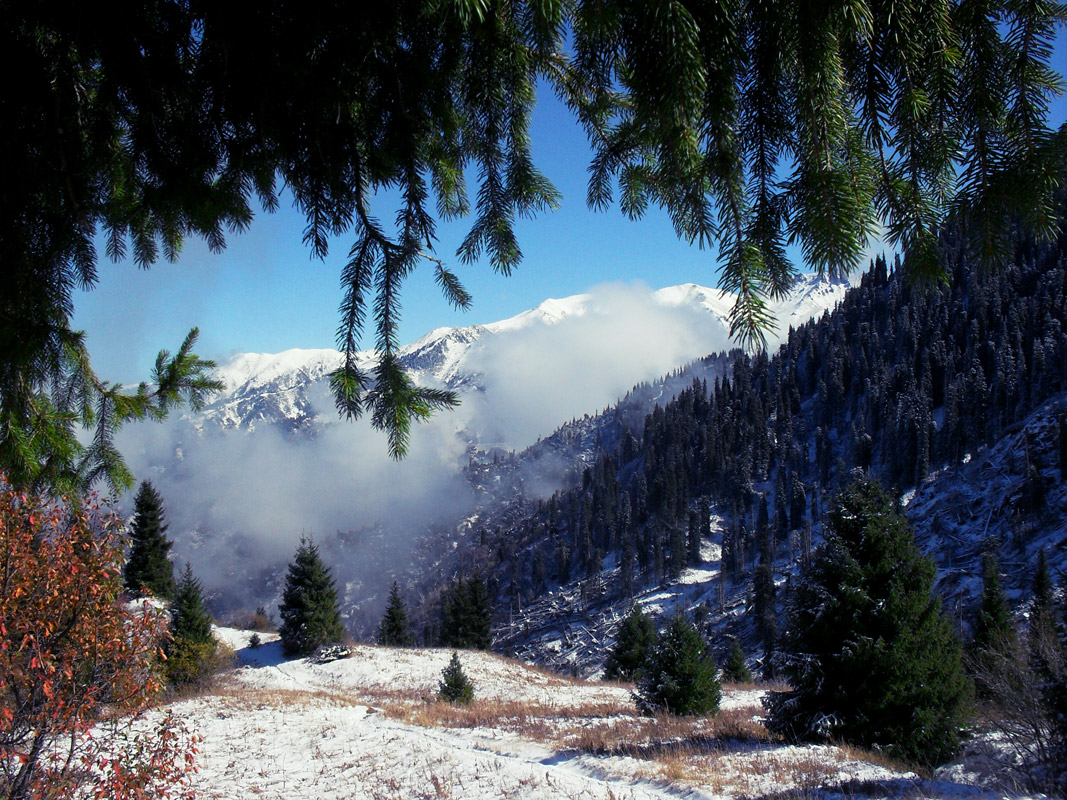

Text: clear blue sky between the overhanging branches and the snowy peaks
xmin=74 ymin=36 xmax=1067 ymax=383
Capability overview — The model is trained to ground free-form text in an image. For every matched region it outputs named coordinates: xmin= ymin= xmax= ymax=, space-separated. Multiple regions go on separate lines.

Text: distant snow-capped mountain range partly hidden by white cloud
xmin=198 ymin=275 xmax=849 ymax=434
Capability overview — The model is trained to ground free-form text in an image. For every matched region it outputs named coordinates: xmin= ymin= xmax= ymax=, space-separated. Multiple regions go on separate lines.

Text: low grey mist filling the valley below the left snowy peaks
xmin=113 ymin=392 xmax=469 ymax=610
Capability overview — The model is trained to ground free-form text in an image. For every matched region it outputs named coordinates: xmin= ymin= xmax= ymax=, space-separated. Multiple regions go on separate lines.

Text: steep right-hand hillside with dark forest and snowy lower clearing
xmin=448 ymin=222 xmax=1067 ymax=674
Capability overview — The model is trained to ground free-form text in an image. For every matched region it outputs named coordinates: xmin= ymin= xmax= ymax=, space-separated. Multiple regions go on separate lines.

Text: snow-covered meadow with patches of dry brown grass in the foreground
xmin=131 ymin=628 xmax=1032 ymax=800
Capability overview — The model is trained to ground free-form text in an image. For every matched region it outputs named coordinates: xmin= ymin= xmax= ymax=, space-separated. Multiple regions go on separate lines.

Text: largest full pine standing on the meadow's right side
xmin=766 ymin=479 xmax=971 ymax=764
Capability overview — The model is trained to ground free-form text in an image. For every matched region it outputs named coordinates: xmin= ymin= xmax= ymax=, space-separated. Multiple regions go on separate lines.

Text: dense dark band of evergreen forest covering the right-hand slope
xmin=460 ymin=213 xmax=1067 ymax=647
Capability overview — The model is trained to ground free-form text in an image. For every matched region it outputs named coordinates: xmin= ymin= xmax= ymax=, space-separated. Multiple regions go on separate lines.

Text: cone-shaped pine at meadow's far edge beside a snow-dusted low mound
xmin=278 ymin=537 xmax=345 ymax=656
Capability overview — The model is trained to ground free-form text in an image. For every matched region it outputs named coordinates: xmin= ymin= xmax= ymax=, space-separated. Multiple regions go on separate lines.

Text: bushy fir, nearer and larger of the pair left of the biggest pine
xmin=634 ymin=614 xmax=722 ymax=717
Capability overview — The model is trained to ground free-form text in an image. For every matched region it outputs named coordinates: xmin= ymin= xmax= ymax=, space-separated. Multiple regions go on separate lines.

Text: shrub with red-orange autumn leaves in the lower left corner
xmin=0 ymin=478 xmax=196 ymax=800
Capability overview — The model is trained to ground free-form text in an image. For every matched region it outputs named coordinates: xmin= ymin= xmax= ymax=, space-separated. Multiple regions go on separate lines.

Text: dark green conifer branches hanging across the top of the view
xmin=0 ymin=0 xmax=1067 ymax=489
